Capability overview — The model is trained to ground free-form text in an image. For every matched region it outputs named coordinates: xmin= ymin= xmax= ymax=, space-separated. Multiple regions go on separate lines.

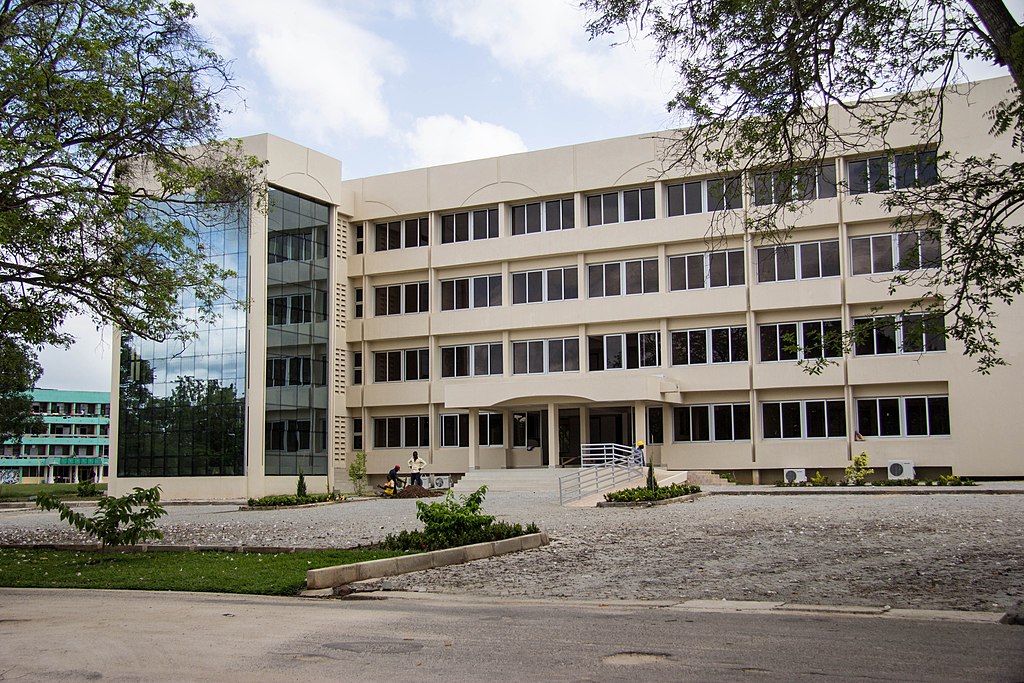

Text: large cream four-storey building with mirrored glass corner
xmin=112 ymin=80 xmax=1024 ymax=498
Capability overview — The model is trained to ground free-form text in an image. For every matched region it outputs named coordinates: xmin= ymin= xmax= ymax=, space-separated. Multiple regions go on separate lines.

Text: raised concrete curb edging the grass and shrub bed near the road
xmin=306 ymin=531 xmax=551 ymax=591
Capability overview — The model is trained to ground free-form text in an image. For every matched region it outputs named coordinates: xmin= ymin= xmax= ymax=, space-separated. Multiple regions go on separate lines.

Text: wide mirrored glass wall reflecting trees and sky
xmin=117 ymin=208 xmax=249 ymax=477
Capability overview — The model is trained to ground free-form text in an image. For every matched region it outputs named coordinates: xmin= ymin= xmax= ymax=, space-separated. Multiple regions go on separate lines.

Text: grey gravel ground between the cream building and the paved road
xmin=0 ymin=492 xmax=1024 ymax=610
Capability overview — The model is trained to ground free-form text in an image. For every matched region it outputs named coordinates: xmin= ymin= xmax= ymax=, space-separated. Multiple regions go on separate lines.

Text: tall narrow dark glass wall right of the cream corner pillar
xmin=264 ymin=187 xmax=330 ymax=476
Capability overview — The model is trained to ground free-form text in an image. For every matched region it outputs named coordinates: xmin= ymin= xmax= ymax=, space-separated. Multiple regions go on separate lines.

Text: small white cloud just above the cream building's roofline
xmin=403 ymin=114 xmax=526 ymax=167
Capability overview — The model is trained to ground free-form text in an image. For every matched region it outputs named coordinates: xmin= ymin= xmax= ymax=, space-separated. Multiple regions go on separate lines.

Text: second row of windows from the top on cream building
xmin=355 ymin=232 xmax=941 ymax=317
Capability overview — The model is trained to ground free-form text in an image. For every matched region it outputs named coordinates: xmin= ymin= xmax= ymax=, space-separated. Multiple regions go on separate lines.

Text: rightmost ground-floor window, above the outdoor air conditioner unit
xmin=857 ymin=396 xmax=949 ymax=436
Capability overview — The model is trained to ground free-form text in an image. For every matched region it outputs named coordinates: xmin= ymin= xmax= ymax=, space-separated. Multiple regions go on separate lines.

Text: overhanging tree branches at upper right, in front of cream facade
xmin=581 ymin=0 xmax=1024 ymax=372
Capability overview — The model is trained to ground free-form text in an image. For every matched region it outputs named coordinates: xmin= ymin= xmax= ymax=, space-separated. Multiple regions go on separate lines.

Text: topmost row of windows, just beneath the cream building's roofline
xmin=356 ymin=151 xmax=938 ymax=252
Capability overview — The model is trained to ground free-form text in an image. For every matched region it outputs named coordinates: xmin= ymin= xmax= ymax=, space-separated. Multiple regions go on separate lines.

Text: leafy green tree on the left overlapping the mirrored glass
xmin=0 ymin=0 xmax=261 ymax=395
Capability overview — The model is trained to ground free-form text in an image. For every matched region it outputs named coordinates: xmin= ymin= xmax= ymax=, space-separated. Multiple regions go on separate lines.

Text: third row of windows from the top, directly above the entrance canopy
xmin=356 ymin=313 xmax=946 ymax=386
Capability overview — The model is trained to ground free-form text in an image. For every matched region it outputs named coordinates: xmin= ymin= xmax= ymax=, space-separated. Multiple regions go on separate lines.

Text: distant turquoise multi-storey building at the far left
xmin=0 ymin=389 xmax=111 ymax=483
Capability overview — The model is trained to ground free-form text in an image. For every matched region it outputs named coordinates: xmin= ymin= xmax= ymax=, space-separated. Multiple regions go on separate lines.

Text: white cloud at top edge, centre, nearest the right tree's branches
xmin=433 ymin=0 xmax=669 ymax=109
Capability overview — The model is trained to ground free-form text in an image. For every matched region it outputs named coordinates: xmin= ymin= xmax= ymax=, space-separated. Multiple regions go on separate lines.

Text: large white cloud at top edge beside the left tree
xmin=195 ymin=0 xmax=404 ymax=144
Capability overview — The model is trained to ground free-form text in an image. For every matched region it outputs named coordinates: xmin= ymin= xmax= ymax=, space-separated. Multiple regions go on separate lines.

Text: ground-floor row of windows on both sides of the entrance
xmin=353 ymin=396 xmax=949 ymax=449
